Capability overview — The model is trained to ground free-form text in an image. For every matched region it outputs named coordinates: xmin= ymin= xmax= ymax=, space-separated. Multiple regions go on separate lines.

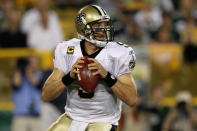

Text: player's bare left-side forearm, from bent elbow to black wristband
xmin=42 ymin=80 xmax=66 ymax=101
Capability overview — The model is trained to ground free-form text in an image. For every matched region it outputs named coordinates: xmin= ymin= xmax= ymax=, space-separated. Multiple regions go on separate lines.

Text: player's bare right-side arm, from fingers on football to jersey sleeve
xmin=88 ymin=58 xmax=137 ymax=106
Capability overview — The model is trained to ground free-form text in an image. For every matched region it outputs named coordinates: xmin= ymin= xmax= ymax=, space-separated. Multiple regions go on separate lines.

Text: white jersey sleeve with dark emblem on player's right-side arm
xmin=117 ymin=47 xmax=136 ymax=76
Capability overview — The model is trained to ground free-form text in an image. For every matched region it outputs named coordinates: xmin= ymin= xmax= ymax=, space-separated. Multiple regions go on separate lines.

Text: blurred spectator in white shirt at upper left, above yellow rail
xmin=22 ymin=0 xmax=63 ymax=51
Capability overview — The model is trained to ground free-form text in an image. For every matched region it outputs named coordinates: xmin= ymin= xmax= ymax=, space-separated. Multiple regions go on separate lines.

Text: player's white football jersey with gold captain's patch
xmin=54 ymin=39 xmax=136 ymax=125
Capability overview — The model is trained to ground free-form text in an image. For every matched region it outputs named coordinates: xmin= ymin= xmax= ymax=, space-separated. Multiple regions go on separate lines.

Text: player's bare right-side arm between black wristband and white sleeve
xmin=112 ymin=76 xmax=137 ymax=106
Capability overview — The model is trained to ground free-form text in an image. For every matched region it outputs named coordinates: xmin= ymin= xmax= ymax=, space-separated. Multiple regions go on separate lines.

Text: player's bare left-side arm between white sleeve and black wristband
xmin=42 ymin=68 xmax=66 ymax=101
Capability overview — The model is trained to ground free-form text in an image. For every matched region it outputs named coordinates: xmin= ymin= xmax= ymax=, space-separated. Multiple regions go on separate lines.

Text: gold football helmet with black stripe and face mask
xmin=75 ymin=5 xmax=114 ymax=47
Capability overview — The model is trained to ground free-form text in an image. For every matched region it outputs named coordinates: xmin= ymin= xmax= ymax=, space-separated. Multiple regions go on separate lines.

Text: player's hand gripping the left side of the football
xmin=70 ymin=57 xmax=84 ymax=79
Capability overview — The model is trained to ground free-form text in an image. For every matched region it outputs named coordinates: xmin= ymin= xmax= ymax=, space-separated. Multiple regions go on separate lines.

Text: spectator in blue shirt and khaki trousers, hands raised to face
xmin=11 ymin=56 xmax=42 ymax=131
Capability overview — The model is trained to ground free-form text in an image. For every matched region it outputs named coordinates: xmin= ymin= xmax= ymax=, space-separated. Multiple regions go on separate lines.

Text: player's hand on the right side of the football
xmin=88 ymin=58 xmax=108 ymax=78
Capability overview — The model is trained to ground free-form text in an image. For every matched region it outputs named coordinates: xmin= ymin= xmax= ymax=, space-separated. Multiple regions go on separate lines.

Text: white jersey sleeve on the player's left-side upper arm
xmin=53 ymin=43 xmax=66 ymax=72
